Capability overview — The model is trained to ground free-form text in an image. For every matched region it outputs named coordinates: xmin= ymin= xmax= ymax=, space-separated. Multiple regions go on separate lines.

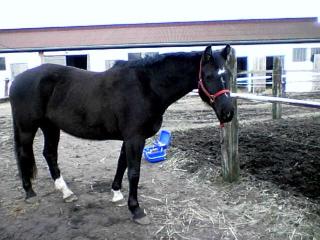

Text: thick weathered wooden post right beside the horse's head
xmin=220 ymin=49 xmax=240 ymax=182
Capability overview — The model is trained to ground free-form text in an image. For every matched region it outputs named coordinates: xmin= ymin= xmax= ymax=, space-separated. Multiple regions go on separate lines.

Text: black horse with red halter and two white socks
xmin=10 ymin=45 xmax=233 ymax=224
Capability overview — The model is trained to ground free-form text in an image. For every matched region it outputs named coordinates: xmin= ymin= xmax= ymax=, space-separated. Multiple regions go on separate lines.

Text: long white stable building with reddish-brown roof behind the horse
xmin=0 ymin=18 xmax=320 ymax=98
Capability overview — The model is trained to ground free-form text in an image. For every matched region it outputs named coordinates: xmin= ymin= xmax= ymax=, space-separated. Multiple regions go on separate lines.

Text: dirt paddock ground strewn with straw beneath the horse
xmin=0 ymin=96 xmax=320 ymax=240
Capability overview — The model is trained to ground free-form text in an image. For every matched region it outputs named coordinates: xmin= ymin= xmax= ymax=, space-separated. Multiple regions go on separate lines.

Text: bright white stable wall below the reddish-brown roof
xmin=0 ymin=43 xmax=320 ymax=98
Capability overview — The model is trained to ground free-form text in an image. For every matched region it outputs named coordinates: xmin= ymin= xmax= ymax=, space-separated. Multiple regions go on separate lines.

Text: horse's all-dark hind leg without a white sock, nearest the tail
xmin=14 ymin=123 xmax=37 ymax=200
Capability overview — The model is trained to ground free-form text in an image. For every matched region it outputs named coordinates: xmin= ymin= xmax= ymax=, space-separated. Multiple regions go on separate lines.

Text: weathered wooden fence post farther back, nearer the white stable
xmin=272 ymin=57 xmax=282 ymax=119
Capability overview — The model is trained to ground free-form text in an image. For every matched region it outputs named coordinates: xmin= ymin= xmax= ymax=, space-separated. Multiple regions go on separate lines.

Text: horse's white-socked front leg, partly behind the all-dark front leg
xmin=111 ymin=142 xmax=127 ymax=206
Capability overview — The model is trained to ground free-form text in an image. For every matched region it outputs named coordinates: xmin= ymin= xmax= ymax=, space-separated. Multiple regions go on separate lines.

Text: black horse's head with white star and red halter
xmin=198 ymin=45 xmax=234 ymax=123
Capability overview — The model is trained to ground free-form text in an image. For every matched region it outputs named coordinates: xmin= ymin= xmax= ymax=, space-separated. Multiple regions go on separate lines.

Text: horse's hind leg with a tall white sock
xmin=41 ymin=122 xmax=77 ymax=202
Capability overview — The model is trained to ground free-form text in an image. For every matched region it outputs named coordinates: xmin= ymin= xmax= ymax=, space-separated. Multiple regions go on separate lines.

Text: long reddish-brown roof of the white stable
xmin=0 ymin=18 xmax=320 ymax=52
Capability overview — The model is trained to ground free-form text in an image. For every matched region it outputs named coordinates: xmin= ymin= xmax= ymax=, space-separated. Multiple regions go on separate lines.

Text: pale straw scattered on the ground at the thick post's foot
xmin=141 ymin=145 xmax=320 ymax=240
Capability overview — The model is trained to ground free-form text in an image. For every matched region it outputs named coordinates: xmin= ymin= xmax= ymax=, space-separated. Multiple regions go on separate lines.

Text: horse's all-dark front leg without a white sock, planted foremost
xmin=125 ymin=137 xmax=150 ymax=224
